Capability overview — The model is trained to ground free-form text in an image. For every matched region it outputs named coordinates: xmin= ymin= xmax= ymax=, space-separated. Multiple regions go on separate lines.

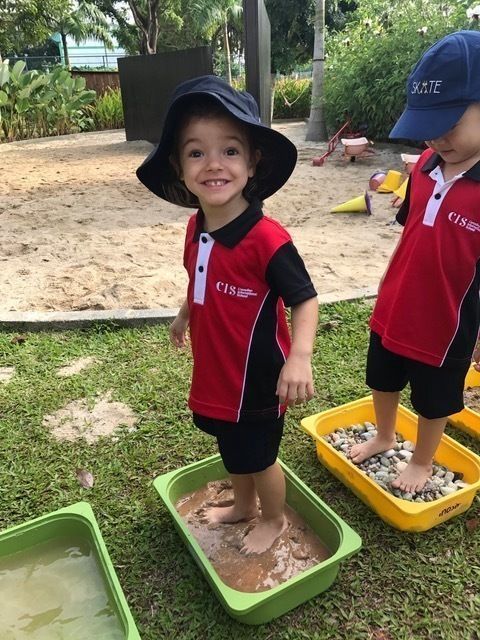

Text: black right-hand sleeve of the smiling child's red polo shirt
xmin=266 ymin=242 xmax=317 ymax=307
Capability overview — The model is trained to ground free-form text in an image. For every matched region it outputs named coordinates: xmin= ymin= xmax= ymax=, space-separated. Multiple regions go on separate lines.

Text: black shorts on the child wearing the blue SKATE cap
xmin=367 ymin=331 xmax=470 ymax=420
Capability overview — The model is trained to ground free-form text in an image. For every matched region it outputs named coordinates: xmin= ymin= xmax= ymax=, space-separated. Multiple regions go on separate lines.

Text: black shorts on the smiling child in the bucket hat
xmin=193 ymin=413 xmax=285 ymax=474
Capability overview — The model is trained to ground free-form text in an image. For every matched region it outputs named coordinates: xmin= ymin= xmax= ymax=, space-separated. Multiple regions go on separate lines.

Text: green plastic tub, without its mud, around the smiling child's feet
xmin=153 ymin=455 xmax=361 ymax=624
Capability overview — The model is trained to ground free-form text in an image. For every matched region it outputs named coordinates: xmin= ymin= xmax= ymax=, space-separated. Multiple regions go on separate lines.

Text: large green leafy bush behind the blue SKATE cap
xmin=324 ymin=0 xmax=478 ymax=139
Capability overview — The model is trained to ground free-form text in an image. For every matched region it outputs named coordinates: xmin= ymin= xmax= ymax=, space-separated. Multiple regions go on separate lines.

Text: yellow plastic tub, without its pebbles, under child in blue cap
xmin=301 ymin=396 xmax=480 ymax=531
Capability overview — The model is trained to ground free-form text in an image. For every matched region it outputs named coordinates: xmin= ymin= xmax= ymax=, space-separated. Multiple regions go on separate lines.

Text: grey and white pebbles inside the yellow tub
xmin=323 ymin=421 xmax=469 ymax=503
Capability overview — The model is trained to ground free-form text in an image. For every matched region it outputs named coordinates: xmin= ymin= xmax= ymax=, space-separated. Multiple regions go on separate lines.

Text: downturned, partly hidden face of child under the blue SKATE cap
xmin=426 ymin=103 xmax=480 ymax=173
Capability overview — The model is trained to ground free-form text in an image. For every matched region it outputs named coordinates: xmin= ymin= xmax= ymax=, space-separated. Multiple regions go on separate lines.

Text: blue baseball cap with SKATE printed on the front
xmin=389 ymin=31 xmax=480 ymax=140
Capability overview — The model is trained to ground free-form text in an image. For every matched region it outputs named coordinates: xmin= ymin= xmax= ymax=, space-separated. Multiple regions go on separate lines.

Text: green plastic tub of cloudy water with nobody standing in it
xmin=0 ymin=502 xmax=140 ymax=640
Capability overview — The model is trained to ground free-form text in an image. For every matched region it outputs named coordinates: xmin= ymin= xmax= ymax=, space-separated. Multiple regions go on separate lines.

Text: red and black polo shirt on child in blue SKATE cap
xmin=370 ymin=149 xmax=480 ymax=366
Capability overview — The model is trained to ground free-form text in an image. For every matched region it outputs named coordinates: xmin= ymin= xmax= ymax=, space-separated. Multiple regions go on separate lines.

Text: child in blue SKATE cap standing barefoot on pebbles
xmin=350 ymin=31 xmax=480 ymax=499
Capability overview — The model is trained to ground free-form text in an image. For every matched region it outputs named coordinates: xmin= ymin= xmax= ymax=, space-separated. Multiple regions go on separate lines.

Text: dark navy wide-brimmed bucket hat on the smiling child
xmin=137 ymin=76 xmax=297 ymax=207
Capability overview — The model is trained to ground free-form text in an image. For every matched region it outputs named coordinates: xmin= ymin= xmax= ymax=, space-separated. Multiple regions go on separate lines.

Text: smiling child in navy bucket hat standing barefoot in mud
xmin=137 ymin=76 xmax=318 ymax=553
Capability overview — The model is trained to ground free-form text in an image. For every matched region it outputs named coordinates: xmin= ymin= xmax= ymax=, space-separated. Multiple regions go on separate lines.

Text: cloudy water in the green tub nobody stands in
xmin=0 ymin=537 xmax=125 ymax=640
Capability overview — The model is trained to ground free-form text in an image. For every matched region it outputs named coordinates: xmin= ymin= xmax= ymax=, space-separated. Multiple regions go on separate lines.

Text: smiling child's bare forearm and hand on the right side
xmin=276 ymin=297 xmax=318 ymax=405
